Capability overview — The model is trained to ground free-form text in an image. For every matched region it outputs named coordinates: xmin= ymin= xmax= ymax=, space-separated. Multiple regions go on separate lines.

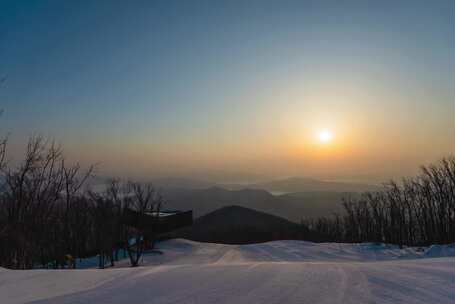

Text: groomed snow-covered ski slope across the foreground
xmin=0 ymin=240 xmax=455 ymax=304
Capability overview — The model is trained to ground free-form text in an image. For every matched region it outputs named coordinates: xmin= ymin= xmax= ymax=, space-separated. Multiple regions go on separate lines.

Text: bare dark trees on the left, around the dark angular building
xmin=0 ymin=137 xmax=162 ymax=269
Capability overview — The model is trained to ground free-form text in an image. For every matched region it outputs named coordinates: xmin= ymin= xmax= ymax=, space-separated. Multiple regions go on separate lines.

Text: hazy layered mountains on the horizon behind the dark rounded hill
xmin=90 ymin=177 xmax=381 ymax=223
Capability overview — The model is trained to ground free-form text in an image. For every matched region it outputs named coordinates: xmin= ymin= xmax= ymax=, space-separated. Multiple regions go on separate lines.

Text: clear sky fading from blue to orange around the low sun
xmin=0 ymin=0 xmax=455 ymax=182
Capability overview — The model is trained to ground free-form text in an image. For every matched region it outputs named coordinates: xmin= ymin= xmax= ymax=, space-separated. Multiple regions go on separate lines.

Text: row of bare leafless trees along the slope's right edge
xmin=306 ymin=158 xmax=455 ymax=246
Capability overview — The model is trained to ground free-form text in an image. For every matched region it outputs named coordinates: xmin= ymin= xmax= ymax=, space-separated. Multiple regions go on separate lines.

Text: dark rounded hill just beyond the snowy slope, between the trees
xmin=169 ymin=206 xmax=309 ymax=244
